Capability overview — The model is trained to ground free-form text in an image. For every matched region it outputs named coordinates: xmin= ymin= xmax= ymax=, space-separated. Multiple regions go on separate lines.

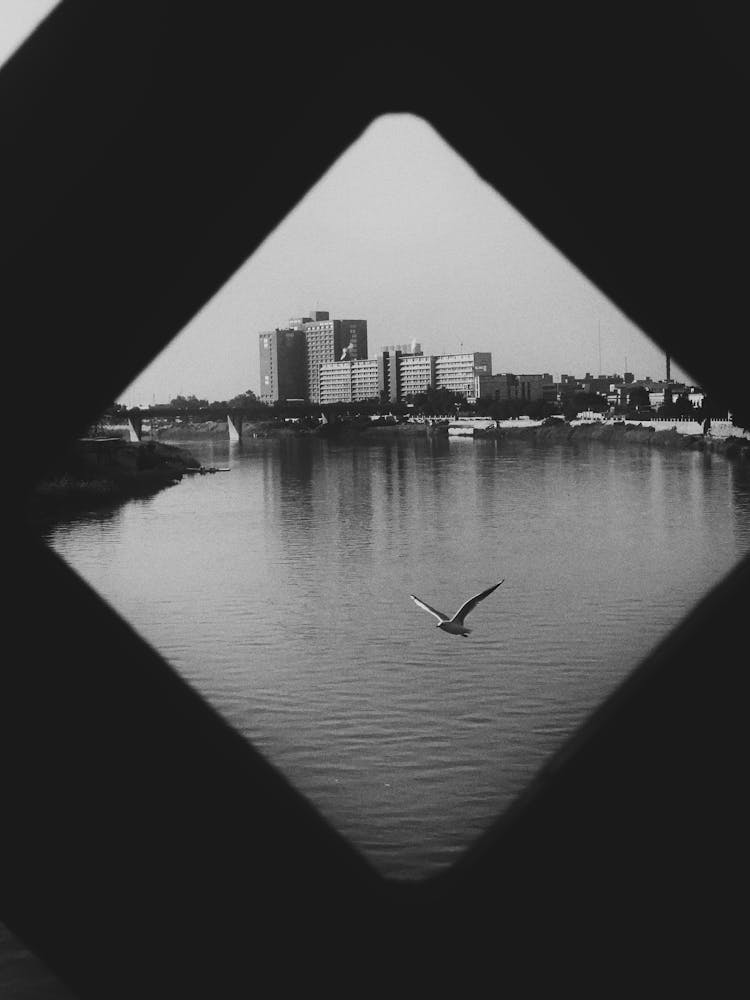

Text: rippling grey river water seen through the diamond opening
xmin=39 ymin=434 xmax=750 ymax=879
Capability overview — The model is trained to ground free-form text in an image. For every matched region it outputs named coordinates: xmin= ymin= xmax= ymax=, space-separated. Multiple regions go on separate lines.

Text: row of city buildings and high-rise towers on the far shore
xmin=259 ymin=311 xmax=704 ymax=412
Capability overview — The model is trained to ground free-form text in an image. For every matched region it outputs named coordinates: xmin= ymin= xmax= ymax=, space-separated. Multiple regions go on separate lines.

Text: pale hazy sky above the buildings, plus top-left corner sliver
xmin=0 ymin=6 xmax=682 ymax=405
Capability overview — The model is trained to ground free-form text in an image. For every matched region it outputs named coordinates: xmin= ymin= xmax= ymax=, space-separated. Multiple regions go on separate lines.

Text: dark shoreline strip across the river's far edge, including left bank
xmin=29 ymin=417 xmax=750 ymax=521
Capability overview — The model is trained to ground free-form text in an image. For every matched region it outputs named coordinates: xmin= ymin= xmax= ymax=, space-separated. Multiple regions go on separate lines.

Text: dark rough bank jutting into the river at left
xmin=31 ymin=437 xmax=201 ymax=513
